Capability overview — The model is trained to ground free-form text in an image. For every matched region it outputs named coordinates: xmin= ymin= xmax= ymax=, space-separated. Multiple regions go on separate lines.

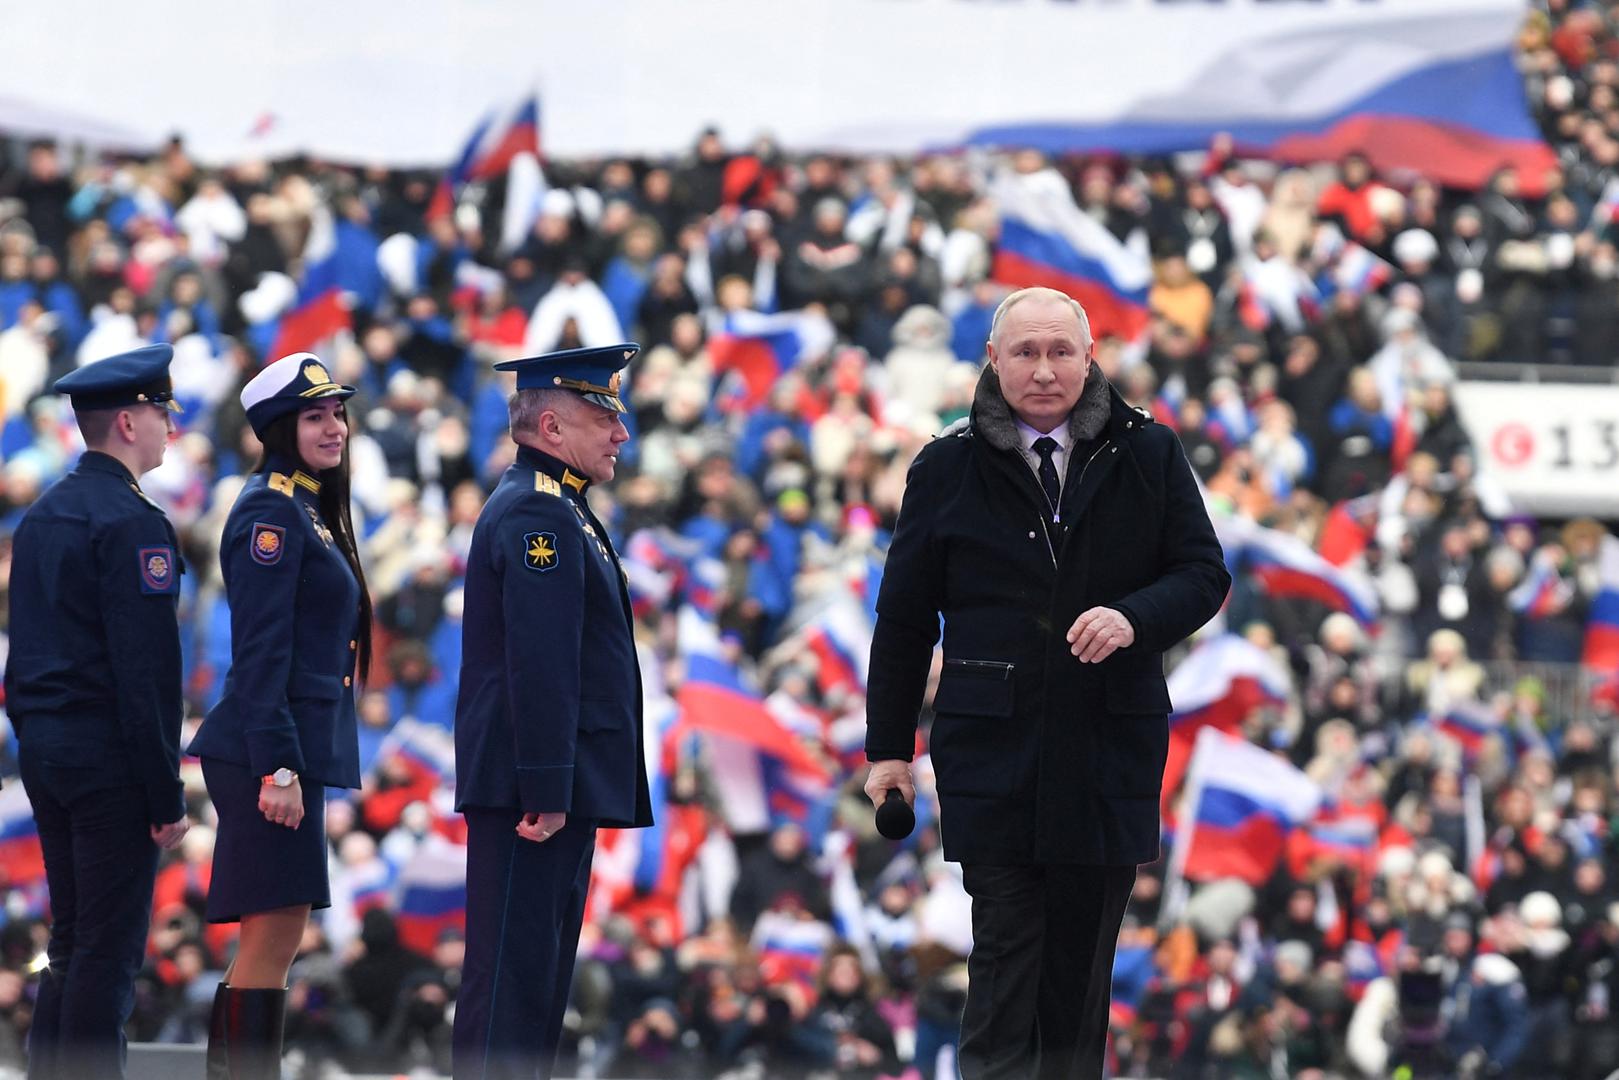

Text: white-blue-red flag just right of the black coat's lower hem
xmin=1177 ymin=729 xmax=1321 ymax=886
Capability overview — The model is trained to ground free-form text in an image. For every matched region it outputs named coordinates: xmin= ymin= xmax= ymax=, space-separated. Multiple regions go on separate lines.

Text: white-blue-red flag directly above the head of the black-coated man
xmin=991 ymin=168 xmax=1153 ymax=342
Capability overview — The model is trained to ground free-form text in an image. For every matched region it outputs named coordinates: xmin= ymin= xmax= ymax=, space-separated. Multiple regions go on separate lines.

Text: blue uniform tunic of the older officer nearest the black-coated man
xmin=455 ymin=447 xmax=652 ymax=827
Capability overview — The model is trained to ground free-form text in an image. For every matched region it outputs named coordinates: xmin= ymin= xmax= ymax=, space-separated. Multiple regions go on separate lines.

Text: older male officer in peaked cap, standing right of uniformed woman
xmin=453 ymin=345 xmax=652 ymax=1080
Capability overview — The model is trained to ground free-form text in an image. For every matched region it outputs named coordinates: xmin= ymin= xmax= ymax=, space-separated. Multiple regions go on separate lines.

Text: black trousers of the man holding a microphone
xmin=958 ymin=863 xmax=1135 ymax=1080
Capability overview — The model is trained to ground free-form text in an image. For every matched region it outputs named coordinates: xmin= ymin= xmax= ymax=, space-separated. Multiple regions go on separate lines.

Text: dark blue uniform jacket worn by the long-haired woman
xmin=189 ymin=460 xmax=359 ymax=790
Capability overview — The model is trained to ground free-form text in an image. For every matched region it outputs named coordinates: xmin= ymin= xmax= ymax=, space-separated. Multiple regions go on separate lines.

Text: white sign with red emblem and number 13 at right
xmin=1455 ymin=382 xmax=1619 ymax=517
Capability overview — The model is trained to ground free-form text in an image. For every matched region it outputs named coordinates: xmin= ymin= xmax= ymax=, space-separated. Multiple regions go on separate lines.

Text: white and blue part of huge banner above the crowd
xmin=0 ymin=0 xmax=1533 ymax=165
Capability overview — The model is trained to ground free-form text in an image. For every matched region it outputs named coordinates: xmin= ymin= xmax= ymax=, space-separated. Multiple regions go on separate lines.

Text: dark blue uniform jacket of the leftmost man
xmin=5 ymin=452 xmax=185 ymax=824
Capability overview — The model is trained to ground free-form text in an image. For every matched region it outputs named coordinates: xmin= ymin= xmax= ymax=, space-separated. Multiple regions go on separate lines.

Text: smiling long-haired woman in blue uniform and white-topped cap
xmin=189 ymin=353 xmax=371 ymax=1080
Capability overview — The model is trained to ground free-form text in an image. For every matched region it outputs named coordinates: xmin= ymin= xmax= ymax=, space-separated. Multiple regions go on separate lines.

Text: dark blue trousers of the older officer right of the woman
xmin=452 ymin=808 xmax=596 ymax=1080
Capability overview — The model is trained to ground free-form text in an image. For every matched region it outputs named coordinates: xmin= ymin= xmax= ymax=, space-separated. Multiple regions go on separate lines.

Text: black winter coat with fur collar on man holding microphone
xmin=866 ymin=368 xmax=1230 ymax=866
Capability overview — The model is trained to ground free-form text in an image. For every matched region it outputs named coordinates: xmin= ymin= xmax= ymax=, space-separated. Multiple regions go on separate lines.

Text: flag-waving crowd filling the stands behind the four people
xmin=0 ymin=8 xmax=1619 ymax=1077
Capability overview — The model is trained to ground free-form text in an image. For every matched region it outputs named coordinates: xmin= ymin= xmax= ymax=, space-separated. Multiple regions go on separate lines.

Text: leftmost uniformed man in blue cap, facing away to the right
xmin=5 ymin=345 xmax=186 ymax=1080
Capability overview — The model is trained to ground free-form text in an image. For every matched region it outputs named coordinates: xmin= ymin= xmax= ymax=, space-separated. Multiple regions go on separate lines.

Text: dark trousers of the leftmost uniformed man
xmin=19 ymin=748 xmax=157 ymax=1080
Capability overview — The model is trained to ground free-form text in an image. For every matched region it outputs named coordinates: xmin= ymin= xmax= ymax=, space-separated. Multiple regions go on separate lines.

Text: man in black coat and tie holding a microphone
xmin=866 ymin=288 xmax=1230 ymax=1080
